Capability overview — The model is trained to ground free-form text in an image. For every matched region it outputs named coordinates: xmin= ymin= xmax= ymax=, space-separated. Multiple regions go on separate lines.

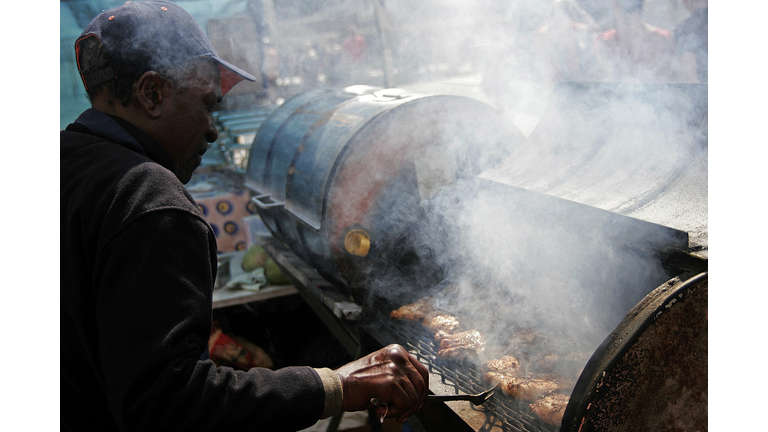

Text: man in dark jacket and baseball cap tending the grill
xmin=60 ymin=2 xmax=428 ymax=431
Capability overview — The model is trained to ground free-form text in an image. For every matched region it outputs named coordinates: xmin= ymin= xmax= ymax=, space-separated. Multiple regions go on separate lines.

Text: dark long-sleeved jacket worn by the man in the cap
xmin=60 ymin=110 xmax=325 ymax=431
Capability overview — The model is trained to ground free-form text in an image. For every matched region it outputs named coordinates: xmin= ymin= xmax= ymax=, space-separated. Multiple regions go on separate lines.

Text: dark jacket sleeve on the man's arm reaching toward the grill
xmin=93 ymin=209 xmax=327 ymax=431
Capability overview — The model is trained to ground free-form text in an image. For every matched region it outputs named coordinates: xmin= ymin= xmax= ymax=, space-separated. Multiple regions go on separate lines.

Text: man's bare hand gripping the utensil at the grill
xmin=335 ymin=345 xmax=429 ymax=423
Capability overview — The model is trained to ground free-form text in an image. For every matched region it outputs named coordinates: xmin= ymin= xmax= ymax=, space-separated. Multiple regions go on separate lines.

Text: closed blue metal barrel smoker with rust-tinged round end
xmin=246 ymin=86 xmax=521 ymax=301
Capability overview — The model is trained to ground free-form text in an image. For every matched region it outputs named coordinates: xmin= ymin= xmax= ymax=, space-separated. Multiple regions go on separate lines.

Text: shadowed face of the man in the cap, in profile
xmin=155 ymin=59 xmax=222 ymax=184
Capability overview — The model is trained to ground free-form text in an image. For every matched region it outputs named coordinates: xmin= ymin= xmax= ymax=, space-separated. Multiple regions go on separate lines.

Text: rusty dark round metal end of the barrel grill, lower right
xmin=561 ymin=273 xmax=708 ymax=432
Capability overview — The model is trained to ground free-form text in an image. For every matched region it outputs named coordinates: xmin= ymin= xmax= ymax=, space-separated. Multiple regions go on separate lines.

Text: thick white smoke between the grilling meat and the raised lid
xmin=408 ymin=179 xmax=668 ymax=350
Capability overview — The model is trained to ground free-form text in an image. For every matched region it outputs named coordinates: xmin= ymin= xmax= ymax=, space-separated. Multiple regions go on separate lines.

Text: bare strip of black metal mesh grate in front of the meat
xmin=372 ymin=320 xmax=558 ymax=432
